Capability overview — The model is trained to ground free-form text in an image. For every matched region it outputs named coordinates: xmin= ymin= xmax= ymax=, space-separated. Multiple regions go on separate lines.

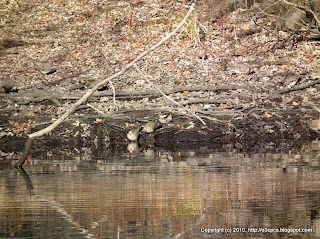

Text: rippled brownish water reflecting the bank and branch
xmin=0 ymin=142 xmax=320 ymax=238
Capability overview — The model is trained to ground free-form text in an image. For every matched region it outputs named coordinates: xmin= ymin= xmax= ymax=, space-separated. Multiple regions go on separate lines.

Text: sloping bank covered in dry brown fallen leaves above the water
xmin=0 ymin=0 xmax=320 ymax=161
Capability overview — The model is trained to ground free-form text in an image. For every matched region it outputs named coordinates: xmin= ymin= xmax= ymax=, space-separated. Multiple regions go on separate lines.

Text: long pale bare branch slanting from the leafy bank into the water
xmin=15 ymin=3 xmax=195 ymax=167
